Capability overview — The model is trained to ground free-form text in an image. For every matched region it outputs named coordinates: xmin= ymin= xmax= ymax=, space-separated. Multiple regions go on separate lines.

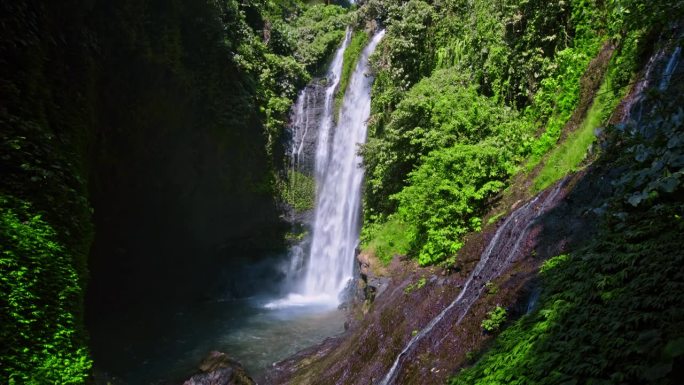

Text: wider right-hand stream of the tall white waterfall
xmin=302 ymin=31 xmax=384 ymax=304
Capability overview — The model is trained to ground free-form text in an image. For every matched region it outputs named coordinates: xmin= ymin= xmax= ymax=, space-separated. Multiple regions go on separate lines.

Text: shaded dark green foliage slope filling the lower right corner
xmin=451 ymin=100 xmax=684 ymax=385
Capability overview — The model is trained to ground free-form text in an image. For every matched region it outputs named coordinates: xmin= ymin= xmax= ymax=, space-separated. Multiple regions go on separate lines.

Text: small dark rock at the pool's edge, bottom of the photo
xmin=183 ymin=351 xmax=256 ymax=385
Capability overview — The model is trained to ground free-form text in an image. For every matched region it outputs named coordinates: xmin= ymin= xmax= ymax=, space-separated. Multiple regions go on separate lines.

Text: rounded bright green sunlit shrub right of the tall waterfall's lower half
xmin=392 ymin=143 xmax=511 ymax=265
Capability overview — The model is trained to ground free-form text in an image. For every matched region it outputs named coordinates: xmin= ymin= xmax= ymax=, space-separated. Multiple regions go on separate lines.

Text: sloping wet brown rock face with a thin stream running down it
xmin=263 ymin=181 xmax=573 ymax=385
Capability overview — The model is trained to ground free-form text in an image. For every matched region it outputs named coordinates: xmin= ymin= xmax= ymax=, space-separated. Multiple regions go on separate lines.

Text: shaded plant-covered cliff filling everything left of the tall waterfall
xmin=0 ymin=0 xmax=348 ymax=384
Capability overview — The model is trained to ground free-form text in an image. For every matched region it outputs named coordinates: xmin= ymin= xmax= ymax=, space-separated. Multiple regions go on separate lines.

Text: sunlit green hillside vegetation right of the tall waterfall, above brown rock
xmin=359 ymin=0 xmax=682 ymax=265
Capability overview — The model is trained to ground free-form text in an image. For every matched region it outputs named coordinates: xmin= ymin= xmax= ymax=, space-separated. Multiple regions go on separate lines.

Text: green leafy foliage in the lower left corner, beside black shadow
xmin=0 ymin=196 xmax=91 ymax=384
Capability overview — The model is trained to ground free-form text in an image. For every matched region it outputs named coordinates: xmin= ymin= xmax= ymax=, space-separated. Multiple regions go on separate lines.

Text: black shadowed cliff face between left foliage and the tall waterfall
xmin=87 ymin=2 xmax=292 ymax=323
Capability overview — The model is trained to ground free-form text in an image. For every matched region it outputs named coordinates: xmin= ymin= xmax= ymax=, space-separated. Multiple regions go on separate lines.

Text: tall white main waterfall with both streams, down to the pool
xmin=266 ymin=31 xmax=385 ymax=308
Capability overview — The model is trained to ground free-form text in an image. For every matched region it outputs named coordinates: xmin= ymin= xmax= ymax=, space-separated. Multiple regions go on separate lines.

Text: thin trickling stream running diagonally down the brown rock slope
xmin=378 ymin=181 xmax=564 ymax=385
